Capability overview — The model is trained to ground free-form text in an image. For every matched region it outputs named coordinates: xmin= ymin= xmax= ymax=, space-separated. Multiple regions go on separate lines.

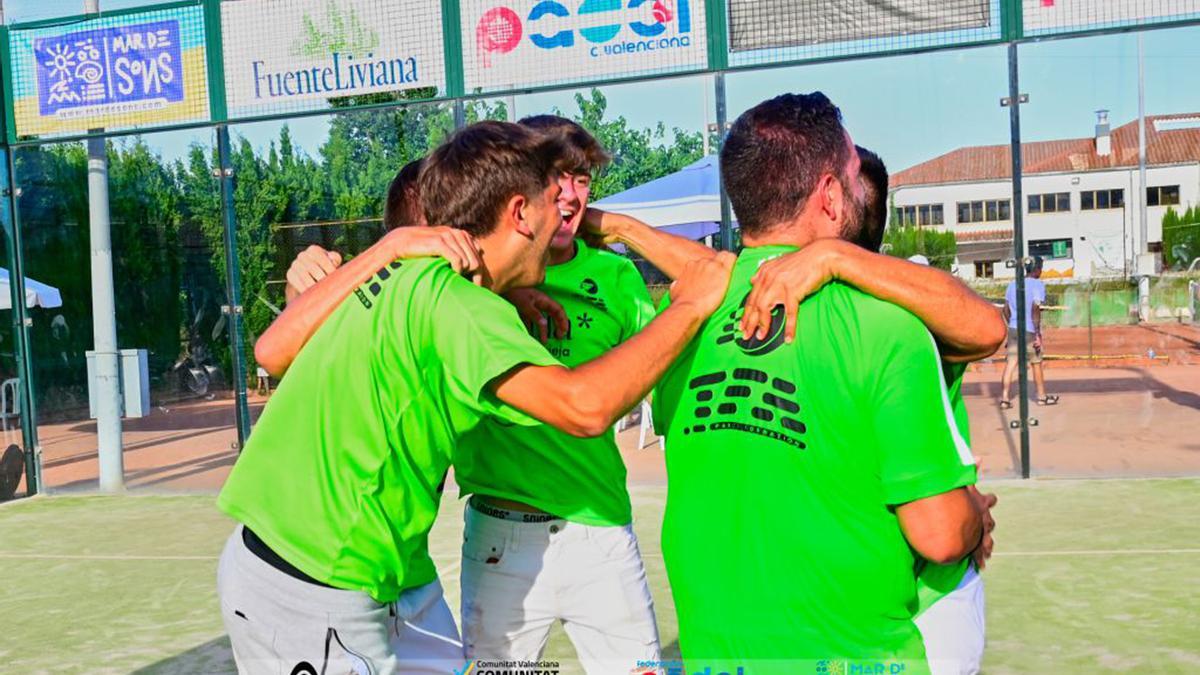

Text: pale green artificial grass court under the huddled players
xmin=0 ymin=478 xmax=1200 ymax=675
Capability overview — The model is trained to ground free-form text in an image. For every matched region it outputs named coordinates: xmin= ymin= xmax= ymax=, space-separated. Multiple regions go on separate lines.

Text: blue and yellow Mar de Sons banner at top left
xmin=11 ymin=7 xmax=209 ymax=136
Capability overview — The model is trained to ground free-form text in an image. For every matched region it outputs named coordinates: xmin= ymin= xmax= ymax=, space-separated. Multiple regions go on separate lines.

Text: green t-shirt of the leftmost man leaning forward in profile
xmin=217 ymin=258 xmax=557 ymax=602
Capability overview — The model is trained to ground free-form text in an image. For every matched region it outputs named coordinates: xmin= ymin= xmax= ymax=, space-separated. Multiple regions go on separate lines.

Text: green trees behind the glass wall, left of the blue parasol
xmin=16 ymin=90 xmax=703 ymax=403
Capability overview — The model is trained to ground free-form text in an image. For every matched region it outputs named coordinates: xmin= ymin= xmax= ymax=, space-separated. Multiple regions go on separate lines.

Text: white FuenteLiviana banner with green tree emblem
xmin=221 ymin=0 xmax=445 ymax=112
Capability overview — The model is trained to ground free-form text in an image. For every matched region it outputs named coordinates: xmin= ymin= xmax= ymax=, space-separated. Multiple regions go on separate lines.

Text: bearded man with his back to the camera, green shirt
xmin=589 ymin=94 xmax=998 ymax=673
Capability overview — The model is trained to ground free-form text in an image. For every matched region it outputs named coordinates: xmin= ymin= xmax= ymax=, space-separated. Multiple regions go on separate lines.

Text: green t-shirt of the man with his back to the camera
xmin=654 ymin=246 xmax=976 ymax=673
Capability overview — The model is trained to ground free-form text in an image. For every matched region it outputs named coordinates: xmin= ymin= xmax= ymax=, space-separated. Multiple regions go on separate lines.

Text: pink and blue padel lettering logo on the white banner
xmin=475 ymin=0 xmax=691 ymax=67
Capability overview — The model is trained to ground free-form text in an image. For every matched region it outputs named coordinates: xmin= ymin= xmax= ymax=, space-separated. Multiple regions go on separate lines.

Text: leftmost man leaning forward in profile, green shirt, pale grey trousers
xmin=217 ymin=123 xmax=730 ymax=673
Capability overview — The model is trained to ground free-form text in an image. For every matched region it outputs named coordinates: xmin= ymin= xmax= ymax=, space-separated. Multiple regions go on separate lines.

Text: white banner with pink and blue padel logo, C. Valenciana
xmin=462 ymin=0 xmax=708 ymax=91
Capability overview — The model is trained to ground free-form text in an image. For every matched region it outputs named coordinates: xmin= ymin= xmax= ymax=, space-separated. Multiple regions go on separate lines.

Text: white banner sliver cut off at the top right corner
xmin=1022 ymin=0 xmax=1200 ymax=36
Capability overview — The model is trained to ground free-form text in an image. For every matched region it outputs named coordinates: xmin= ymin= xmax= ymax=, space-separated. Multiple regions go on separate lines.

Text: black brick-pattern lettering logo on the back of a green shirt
xmin=683 ymin=368 xmax=808 ymax=450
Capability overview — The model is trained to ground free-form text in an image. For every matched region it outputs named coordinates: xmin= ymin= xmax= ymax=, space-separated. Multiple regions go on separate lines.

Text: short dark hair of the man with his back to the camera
xmin=721 ymin=91 xmax=851 ymax=234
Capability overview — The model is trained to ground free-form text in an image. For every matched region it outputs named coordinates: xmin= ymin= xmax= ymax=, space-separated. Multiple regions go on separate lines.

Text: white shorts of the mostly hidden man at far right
xmin=916 ymin=565 xmax=985 ymax=675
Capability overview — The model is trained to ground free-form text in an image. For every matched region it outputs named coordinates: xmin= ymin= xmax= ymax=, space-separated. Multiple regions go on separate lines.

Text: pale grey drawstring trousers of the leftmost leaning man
xmin=217 ymin=525 xmax=466 ymax=675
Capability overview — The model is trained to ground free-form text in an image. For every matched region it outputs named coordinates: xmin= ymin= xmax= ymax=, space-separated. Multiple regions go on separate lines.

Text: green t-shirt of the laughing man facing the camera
xmin=455 ymin=241 xmax=654 ymax=526
